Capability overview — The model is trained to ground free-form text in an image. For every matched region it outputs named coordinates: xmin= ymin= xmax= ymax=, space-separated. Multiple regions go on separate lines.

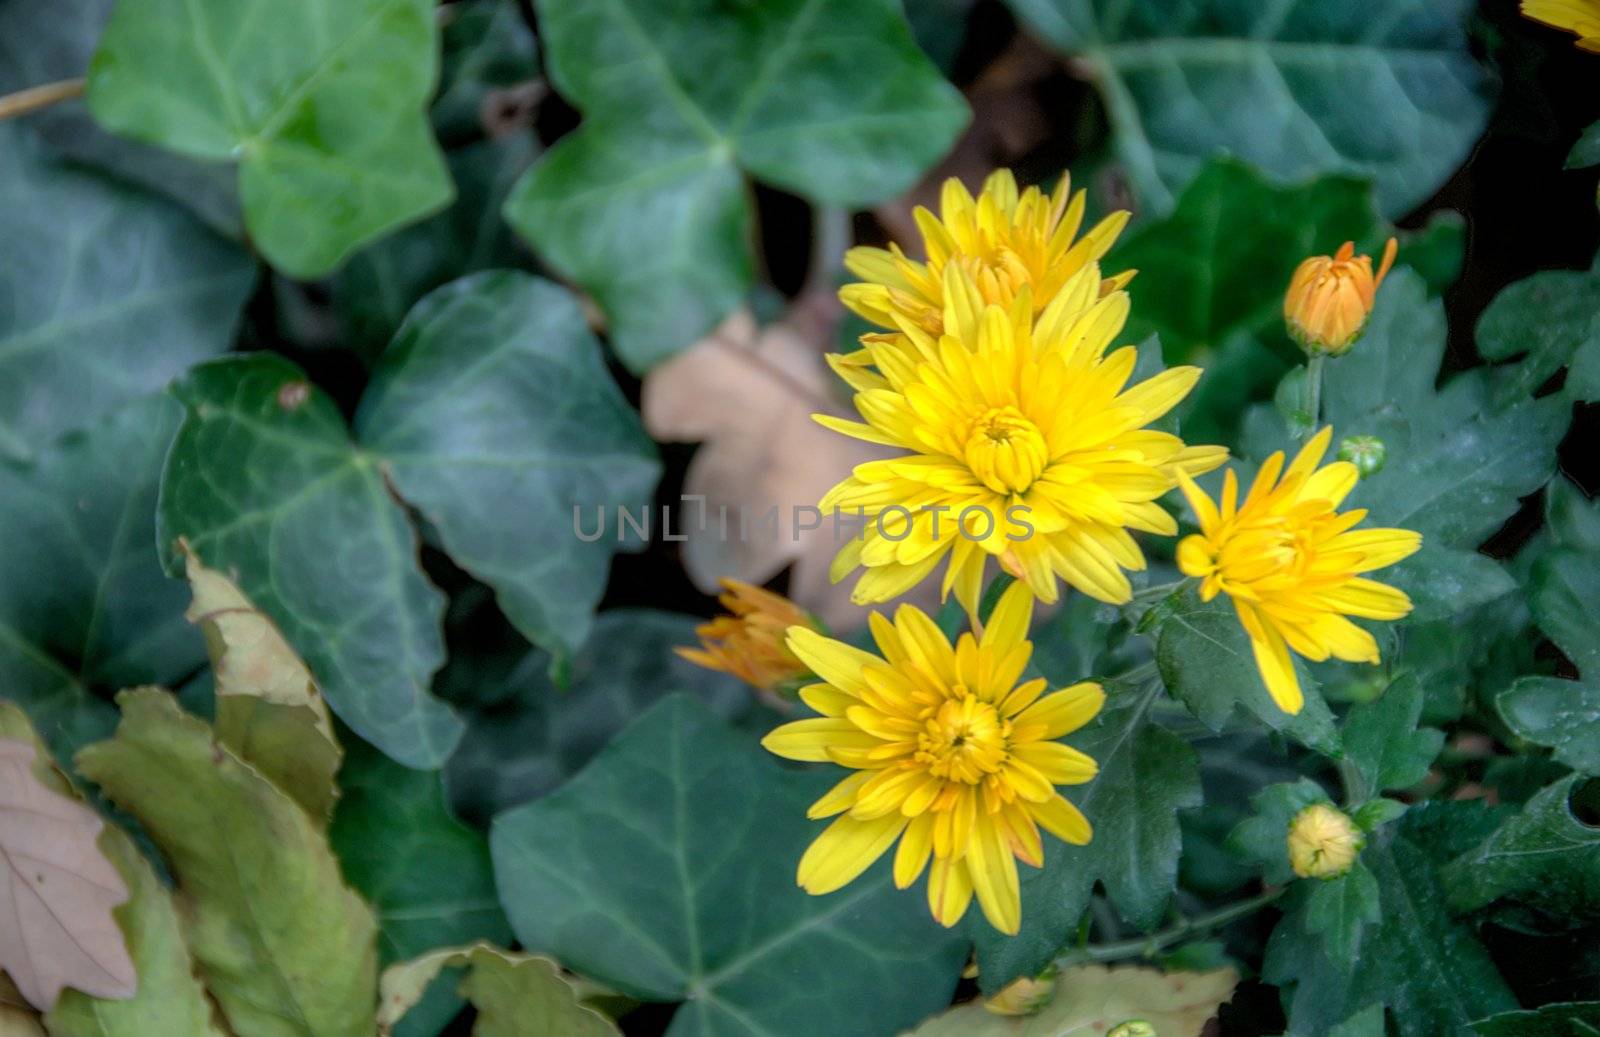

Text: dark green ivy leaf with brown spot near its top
xmin=157 ymin=354 xmax=461 ymax=767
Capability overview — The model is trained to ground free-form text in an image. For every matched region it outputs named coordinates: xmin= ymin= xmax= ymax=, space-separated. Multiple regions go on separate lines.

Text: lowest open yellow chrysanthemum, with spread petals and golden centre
xmin=762 ymin=584 xmax=1106 ymax=933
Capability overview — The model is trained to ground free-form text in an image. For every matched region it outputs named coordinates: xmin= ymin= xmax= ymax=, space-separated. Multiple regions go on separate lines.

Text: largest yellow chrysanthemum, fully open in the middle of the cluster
xmin=816 ymin=264 xmax=1227 ymax=613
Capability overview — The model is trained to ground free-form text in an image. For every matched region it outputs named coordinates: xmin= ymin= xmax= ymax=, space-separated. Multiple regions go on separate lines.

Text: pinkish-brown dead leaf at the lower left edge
xmin=0 ymin=738 xmax=138 ymax=1010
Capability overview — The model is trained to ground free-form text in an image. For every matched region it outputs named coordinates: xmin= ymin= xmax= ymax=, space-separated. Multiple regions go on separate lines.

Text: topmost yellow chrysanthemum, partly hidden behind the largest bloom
xmin=838 ymin=170 xmax=1133 ymax=334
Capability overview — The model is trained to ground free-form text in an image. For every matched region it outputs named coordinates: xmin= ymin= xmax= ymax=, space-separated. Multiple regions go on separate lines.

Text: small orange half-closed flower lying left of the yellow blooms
xmin=677 ymin=579 xmax=816 ymax=691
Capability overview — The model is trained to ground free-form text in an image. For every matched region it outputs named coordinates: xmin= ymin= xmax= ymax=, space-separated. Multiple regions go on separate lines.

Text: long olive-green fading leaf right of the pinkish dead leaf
xmin=77 ymin=688 xmax=378 ymax=1037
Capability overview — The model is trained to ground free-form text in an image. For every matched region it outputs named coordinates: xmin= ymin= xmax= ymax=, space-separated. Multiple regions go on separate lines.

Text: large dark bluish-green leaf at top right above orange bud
xmin=1010 ymin=0 xmax=1494 ymax=216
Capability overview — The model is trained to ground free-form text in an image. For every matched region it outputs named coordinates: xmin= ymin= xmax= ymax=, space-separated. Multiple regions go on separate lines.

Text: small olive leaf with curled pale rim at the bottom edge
xmin=378 ymin=943 xmax=618 ymax=1037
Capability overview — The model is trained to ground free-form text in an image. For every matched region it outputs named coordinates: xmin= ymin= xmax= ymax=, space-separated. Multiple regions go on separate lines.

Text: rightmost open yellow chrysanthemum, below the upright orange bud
xmin=1178 ymin=426 xmax=1422 ymax=714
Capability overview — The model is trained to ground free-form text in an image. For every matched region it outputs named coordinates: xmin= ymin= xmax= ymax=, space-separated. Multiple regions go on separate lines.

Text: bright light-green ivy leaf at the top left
xmin=88 ymin=0 xmax=451 ymax=278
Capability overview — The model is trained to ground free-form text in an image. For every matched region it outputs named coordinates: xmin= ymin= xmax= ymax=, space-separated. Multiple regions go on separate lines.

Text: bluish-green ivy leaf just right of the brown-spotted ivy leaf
xmin=355 ymin=270 xmax=661 ymax=658
